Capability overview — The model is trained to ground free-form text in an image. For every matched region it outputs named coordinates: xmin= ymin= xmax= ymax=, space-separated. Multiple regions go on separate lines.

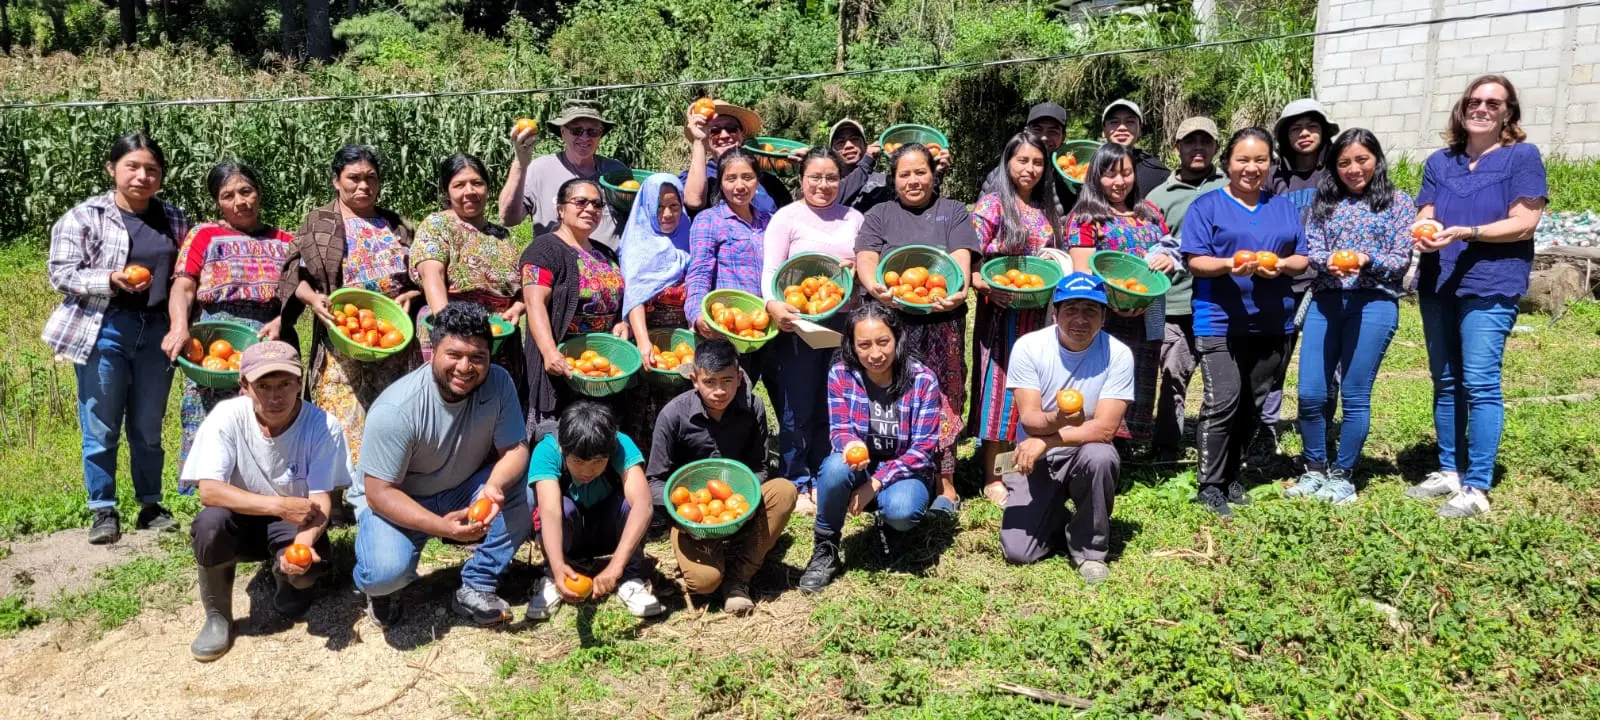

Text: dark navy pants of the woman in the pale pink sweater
xmin=762 ymin=333 xmax=834 ymax=491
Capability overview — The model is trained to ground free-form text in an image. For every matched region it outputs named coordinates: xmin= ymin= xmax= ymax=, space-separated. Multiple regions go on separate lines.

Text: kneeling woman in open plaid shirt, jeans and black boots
xmin=800 ymin=304 xmax=944 ymax=592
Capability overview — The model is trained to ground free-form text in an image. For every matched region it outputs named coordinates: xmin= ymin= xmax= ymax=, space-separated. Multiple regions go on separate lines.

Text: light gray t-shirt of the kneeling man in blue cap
xmin=1005 ymin=325 xmax=1133 ymax=440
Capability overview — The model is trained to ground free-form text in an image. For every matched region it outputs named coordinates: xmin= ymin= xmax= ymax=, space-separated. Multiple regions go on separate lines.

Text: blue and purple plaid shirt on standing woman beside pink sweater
xmin=683 ymin=203 xmax=773 ymax=326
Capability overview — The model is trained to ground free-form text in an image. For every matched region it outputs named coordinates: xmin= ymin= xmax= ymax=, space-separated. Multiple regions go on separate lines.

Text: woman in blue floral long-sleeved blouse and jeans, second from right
xmin=1285 ymin=128 xmax=1416 ymax=506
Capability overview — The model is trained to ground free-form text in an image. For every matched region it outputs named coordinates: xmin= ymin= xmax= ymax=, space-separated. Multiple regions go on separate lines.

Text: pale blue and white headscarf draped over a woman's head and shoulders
xmin=618 ymin=173 xmax=690 ymax=317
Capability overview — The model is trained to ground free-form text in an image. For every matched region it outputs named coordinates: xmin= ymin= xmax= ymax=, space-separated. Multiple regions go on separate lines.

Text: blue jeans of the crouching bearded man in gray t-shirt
xmin=350 ymin=466 xmax=533 ymax=597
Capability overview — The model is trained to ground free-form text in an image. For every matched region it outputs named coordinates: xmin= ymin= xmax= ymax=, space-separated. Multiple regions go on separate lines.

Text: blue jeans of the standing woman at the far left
xmin=74 ymin=307 xmax=173 ymax=510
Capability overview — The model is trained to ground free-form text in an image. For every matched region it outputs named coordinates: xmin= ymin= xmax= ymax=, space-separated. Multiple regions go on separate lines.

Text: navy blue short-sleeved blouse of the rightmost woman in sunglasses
xmin=1416 ymin=142 xmax=1549 ymax=298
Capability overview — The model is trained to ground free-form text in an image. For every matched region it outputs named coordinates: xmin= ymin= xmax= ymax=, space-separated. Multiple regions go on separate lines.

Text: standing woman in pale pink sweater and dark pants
xmin=762 ymin=147 xmax=861 ymax=512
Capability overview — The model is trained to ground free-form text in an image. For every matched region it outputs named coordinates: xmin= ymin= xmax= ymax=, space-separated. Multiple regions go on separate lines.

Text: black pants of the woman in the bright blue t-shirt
xmin=1195 ymin=334 xmax=1293 ymax=490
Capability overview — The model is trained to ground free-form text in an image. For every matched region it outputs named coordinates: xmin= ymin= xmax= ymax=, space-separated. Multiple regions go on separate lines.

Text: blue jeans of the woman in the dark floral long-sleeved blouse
xmin=1299 ymin=290 xmax=1400 ymax=470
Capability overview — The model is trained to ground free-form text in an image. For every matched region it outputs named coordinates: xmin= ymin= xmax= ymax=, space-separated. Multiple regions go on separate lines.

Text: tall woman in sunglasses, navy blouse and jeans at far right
xmin=1406 ymin=75 xmax=1549 ymax=517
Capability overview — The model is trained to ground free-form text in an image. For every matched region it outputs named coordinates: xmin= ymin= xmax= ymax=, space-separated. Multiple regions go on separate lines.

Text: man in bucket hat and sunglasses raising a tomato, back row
xmin=499 ymin=99 xmax=629 ymax=248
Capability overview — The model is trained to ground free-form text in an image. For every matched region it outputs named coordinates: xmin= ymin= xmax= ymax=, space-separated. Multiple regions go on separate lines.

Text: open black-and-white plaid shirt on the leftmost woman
xmin=40 ymin=192 xmax=189 ymax=365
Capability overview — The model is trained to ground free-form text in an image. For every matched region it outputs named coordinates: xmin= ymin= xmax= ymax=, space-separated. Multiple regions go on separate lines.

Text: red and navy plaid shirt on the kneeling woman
xmin=827 ymin=360 xmax=944 ymax=486
